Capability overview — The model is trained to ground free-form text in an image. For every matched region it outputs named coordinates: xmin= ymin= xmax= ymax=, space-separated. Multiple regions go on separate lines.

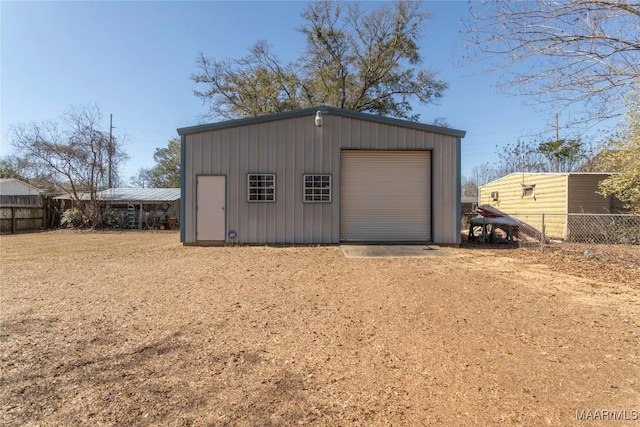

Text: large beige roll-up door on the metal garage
xmin=340 ymin=150 xmax=431 ymax=241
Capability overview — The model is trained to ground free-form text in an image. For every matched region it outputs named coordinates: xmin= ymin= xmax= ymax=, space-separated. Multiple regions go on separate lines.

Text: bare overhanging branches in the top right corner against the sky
xmin=464 ymin=0 xmax=640 ymax=125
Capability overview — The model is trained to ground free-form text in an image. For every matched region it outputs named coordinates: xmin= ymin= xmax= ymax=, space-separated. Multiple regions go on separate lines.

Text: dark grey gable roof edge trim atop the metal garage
xmin=178 ymin=106 xmax=466 ymax=138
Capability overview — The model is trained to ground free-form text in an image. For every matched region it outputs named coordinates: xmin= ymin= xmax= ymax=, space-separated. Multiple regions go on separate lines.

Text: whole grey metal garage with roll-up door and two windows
xmin=178 ymin=107 xmax=465 ymax=245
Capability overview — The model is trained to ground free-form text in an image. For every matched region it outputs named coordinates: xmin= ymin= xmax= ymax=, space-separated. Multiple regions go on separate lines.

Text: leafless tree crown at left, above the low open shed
xmin=10 ymin=106 xmax=127 ymax=202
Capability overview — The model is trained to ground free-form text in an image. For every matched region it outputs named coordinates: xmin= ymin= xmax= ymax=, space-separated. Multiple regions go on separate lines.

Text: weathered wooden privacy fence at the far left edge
xmin=0 ymin=196 xmax=51 ymax=234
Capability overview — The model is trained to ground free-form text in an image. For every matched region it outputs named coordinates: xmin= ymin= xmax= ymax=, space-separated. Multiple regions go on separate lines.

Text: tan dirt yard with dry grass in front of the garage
xmin=0 ymin=232 xmax=640 ymax=426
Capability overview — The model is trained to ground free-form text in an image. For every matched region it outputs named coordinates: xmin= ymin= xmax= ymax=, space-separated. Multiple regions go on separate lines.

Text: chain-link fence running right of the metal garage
xmin=463 ymin=214 xmax=640 ymax=248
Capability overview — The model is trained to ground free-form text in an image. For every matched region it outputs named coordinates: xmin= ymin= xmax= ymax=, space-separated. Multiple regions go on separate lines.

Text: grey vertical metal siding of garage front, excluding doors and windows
xmin=182 ymin=108 xmax=460 ymax=243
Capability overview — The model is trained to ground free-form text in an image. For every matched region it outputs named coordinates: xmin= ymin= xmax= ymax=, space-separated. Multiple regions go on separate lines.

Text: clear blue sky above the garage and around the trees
xmin=0 ymin=0 xmax=612 ymax=183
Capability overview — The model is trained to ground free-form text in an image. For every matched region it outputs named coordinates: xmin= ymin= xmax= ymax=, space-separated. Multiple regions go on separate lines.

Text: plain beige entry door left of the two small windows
xmin=196 ymin=175 xmax=226 ymax=241
